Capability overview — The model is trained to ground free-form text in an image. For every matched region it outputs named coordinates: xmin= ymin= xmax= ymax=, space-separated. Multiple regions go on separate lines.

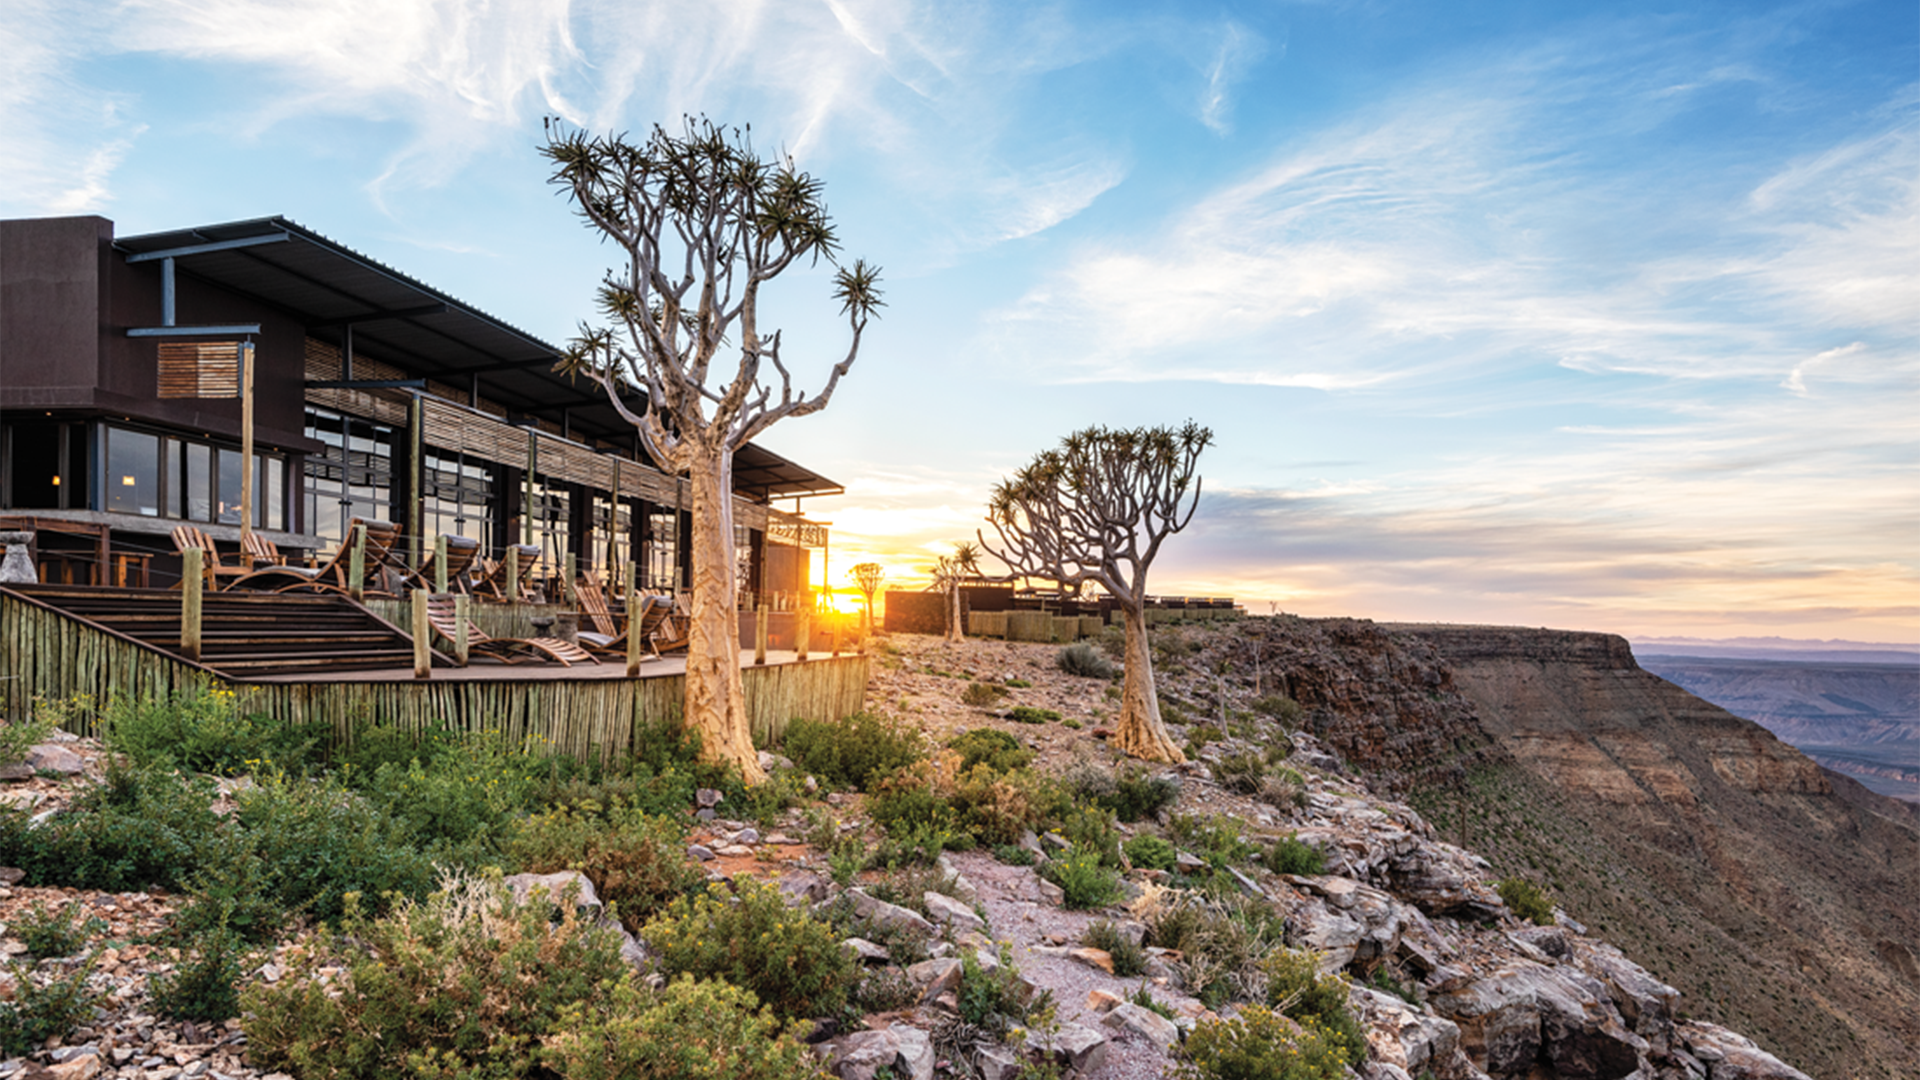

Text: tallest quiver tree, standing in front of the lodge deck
xmin=540 ymin=117 xmax=881 ymax=782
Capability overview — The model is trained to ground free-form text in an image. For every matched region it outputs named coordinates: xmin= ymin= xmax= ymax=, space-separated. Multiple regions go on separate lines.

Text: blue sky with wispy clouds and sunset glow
xmin=0 ymin=0 xmax=1920 ymax=642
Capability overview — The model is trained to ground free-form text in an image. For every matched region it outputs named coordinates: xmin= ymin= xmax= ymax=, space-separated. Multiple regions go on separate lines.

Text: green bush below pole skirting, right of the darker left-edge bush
xmin=234 ymin=776 xmax=434 ymax=920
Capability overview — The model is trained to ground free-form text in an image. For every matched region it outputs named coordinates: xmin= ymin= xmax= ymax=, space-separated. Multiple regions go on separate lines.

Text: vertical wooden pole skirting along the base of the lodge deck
xmin=0 ymin=588 xmax=868 ymax=757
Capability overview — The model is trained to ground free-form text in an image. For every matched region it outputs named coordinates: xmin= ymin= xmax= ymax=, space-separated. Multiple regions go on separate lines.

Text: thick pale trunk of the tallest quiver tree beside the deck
xmin=687 ymin=450 xmax=766 ymax=784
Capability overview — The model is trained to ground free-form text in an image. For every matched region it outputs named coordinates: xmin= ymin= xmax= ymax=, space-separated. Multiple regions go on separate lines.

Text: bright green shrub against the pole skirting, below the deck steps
xmin=100 ymin=684 xmax=330 ymax=776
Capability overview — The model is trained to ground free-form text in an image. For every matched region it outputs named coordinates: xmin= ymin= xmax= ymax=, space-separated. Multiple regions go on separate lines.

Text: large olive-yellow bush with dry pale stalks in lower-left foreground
xmin=240 ymin=876 xmax=630 ymax=1080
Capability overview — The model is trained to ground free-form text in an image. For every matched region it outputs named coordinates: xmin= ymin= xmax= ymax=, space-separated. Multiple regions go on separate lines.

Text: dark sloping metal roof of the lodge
xmin=115 ymin=217 xmax=845 ymax=500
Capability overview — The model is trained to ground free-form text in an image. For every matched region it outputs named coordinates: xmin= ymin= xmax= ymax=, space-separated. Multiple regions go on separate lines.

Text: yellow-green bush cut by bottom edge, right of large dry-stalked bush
xmin=541 ymin=976 xmax=820 ymax=1080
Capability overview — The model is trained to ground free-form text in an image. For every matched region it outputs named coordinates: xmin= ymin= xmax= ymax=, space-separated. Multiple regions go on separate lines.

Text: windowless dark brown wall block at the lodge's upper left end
xmin=0 ymin=217 xmax=113 ymax=409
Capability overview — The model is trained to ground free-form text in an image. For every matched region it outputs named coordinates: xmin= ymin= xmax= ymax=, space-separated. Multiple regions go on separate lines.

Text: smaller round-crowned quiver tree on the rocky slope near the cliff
xmin=981 ymin=421 xmax=1213 ymax=761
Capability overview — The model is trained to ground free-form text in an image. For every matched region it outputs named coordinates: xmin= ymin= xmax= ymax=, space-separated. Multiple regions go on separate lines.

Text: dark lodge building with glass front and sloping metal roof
xmin=0 ymin=217 xmax=841 ymax=609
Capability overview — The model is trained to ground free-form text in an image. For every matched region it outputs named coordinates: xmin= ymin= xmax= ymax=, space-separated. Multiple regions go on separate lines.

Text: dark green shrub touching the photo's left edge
xmin=0 ymin=767 xmax=219 ymax=892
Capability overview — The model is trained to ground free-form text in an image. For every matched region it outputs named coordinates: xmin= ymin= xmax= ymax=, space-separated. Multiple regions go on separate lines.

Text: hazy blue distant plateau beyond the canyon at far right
xmin=1634 ymin=638 xmax=1920 ymax=801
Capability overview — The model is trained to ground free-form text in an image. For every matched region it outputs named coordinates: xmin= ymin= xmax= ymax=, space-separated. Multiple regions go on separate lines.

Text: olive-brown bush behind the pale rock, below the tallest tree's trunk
xmin=507 ymin=805 xmax=703 ymax=928
